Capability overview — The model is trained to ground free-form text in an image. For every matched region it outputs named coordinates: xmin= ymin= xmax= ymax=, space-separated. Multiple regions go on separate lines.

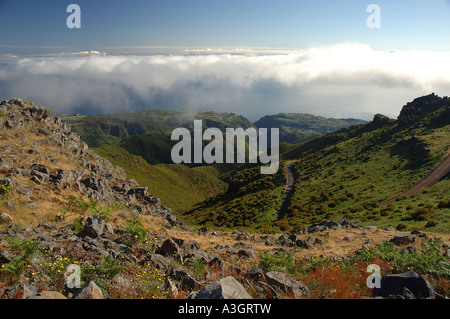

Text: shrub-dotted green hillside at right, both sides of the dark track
xmin=186 ymin=95 xmax=450 ymax=232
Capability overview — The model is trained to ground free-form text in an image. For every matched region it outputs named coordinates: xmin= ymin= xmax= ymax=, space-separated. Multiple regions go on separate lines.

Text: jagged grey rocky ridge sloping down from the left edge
xmin=0 ymin=98 xmax=185 ymax=227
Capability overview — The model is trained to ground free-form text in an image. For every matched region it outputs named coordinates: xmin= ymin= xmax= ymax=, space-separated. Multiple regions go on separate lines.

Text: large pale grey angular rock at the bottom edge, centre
xmin=187 ymin=276 xmax=252 ymax=299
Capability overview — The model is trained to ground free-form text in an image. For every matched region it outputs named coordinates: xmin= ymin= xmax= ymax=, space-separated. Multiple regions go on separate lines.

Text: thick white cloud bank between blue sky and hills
xmin=0 ymin=43 xmax=450 ymax=120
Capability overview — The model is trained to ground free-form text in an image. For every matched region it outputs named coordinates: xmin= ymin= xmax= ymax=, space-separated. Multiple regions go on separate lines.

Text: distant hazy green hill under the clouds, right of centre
xmin=255 ymin=113 xmax=367 ymax=144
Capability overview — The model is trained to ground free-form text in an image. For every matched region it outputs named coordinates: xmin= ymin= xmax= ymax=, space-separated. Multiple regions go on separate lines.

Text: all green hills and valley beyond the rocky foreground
xmin=65 ymin=94 xmax=450 ymax=232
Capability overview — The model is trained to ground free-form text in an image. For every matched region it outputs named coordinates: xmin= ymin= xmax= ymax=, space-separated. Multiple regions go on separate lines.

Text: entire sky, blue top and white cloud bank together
xmin=0 ymin=0 xmax=450 ymax=120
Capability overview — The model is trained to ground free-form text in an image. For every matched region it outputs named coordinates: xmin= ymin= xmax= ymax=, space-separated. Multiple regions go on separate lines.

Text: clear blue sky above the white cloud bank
xmin=0 ymin=0 xmax=450 ymax=53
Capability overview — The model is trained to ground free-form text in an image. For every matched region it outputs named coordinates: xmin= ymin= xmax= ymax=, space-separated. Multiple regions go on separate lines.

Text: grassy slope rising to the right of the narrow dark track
xmin=285 ymin=94 xmax=450 ymax=232
